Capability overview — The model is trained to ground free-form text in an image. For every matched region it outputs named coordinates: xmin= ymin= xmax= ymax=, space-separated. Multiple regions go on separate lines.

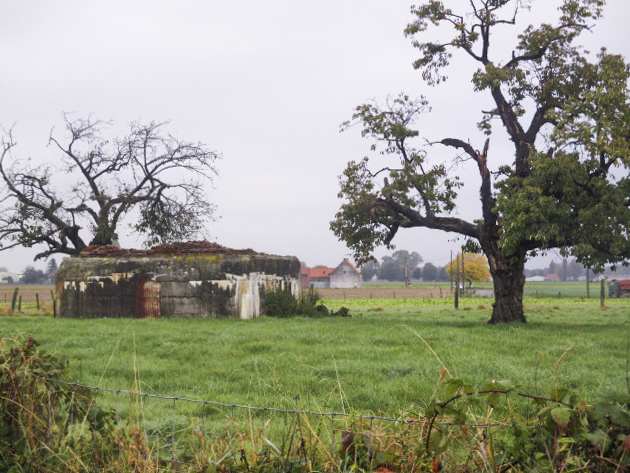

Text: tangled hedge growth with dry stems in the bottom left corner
xmin=0 ymin=337 xmax=120 ymax=471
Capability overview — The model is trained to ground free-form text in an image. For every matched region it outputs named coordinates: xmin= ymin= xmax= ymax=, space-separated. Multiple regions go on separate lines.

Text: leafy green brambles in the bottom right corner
xmin=424 ymin=377 xmax=630 ymax=472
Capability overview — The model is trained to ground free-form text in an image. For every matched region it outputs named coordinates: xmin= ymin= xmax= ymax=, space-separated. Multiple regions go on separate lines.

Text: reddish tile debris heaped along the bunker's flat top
xmin=79 ymin=241 xmax=260 ymax=258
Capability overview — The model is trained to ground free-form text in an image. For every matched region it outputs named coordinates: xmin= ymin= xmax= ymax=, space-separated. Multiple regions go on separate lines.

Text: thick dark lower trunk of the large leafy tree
xmin=488 ymin=249 xmax=527 ymax=324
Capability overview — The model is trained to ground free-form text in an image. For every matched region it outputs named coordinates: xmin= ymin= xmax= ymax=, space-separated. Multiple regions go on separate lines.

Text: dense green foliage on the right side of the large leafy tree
xmin=497 ymin=50 xmax=630 ymax=271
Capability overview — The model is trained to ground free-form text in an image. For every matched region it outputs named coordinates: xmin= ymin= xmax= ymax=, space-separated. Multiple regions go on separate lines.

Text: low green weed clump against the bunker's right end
xmin=263 ymin=287 xmax=350 ymax=318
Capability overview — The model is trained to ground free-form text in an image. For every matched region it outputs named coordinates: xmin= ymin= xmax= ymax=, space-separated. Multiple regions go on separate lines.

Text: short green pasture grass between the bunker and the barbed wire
xmin=0 ymin=299 xmax=630 ymax=414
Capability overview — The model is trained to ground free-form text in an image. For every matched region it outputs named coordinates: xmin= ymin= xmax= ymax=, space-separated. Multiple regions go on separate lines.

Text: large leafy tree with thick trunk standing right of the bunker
xmin=331 ymin=0 xmax=630 ymax=323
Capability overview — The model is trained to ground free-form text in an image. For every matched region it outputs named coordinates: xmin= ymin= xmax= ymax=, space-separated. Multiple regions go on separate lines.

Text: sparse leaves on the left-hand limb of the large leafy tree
xmin=331 ymin=94 xmax=460 ymax=264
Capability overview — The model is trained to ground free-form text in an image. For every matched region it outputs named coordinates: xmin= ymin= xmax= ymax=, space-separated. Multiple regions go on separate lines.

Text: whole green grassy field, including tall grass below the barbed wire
xmin=0 ymin=287 xmax=630 ymax=471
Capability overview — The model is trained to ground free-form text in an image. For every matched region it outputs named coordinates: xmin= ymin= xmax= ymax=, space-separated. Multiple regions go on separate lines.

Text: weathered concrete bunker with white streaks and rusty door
xmin=56 ymin=242 xmax=300 ymax=319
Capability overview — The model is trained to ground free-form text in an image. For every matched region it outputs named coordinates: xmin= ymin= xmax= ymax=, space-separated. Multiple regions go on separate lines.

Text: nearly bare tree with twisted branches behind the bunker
xmin=0 ymin=115 xmax=219 ymax=259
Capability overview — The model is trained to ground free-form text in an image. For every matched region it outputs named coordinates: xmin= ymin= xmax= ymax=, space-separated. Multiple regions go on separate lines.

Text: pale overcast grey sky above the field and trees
xmin=0 ymin=0 xmax=630 ymax=271
